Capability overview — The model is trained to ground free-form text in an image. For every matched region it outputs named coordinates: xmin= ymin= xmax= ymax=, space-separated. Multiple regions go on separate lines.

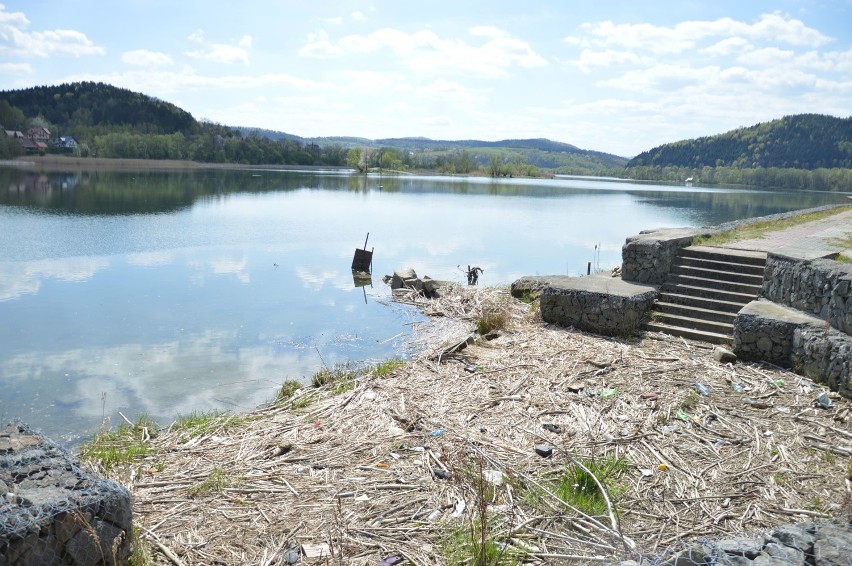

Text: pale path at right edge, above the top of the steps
xmin=721 ymin=209 xmax=852 ymax=259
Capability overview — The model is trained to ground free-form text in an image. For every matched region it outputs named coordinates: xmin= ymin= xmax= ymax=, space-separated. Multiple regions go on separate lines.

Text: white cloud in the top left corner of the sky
xmin=0 ymin=4 xmax=106 ymax=57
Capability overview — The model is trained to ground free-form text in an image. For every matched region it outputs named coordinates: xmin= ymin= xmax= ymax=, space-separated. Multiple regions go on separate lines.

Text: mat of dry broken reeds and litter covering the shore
xmin=98 ymin=286 xmax=852 ymax=566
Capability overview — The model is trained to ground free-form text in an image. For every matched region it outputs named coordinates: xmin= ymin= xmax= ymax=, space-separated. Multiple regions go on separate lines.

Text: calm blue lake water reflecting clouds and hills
xmin=0 ymin=168 xmax=846 ymax=444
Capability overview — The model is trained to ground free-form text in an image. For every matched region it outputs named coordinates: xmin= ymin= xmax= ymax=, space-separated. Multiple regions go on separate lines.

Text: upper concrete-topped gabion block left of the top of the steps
xmin=621 ymin=228 xmax=712 ymax=284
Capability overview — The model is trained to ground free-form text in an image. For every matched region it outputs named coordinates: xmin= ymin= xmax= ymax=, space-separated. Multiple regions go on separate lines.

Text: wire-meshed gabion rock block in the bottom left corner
xmin=0 ymin=424 xmax=132 ymax=566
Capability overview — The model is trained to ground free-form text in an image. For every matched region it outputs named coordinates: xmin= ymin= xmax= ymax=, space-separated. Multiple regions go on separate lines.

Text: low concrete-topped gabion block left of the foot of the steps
xmin=528 ymin=275 xmax=658 ymax=336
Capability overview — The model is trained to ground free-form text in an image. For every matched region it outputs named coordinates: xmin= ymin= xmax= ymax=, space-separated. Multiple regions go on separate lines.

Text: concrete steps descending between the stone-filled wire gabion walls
xmin=645 ymin=246 xmax=766 ymax=345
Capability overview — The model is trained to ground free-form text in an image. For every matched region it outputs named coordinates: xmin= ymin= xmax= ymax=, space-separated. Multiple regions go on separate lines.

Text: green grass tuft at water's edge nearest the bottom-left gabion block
xmin=80 ymin=415 xmax=157 ymax=472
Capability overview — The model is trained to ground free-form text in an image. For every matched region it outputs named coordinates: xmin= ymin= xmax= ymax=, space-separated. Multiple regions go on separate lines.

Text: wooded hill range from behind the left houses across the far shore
xmin=0 ymin=82 xmax=627 ymax=175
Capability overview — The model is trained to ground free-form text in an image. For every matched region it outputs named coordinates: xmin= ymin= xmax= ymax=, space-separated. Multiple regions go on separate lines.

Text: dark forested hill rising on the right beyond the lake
xmin=627 ymin=114 xmax=852 ymax=170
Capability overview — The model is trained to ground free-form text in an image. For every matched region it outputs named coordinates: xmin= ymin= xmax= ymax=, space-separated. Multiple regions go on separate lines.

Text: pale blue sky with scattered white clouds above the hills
xmin=0 ymin=0 xmax=852 ymax=157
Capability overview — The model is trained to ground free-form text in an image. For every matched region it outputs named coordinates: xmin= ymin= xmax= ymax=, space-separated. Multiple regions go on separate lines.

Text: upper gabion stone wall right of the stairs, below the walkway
xmin=762 ymin=254 xmax=852 ymax=334
